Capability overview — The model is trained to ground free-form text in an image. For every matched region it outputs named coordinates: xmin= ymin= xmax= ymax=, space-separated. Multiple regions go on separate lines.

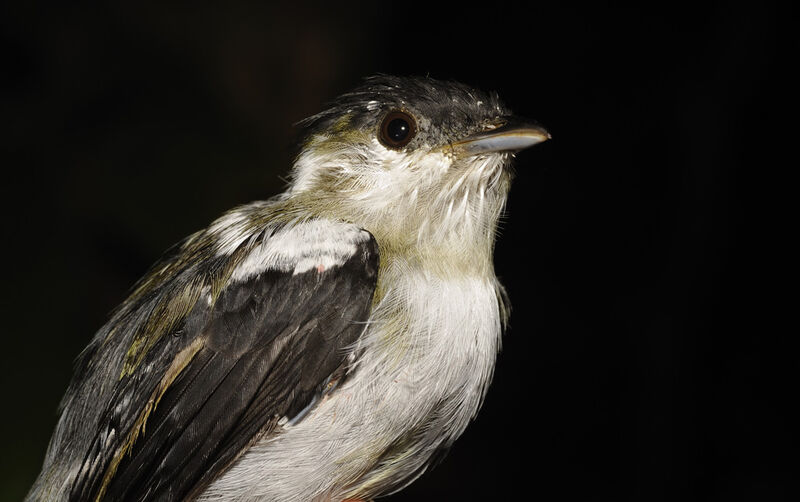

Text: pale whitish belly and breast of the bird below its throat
xmin=201 ymin=278 xmax=500 ymax=501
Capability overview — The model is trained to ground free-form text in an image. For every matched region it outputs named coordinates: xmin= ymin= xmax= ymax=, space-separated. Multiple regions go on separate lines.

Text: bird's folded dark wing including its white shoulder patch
xmin=65 ymin=220 xmax=378 ymax=501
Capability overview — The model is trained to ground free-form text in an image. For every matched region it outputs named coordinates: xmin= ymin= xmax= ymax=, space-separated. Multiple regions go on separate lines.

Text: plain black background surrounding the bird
xmin=0 ymin=2 xmax=798 ymax=501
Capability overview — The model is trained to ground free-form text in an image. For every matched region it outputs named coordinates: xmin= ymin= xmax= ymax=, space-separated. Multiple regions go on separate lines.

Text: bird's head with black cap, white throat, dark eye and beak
xmin=287 ymin=76 xmax=550 ymax=251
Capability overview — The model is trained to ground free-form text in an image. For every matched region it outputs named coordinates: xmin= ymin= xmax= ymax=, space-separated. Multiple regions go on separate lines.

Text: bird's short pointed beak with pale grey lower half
xmin=452 ymin=118 xmax=551 ymax=155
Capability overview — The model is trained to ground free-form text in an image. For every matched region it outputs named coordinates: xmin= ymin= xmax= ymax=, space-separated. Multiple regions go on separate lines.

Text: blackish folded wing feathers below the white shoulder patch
xmin=71 ymin=232 xmax=378 ymax=501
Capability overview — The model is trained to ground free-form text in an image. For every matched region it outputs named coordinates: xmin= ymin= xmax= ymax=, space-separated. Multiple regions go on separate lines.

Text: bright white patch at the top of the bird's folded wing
xmin=231 ymin=220 xmax=370 ymax=281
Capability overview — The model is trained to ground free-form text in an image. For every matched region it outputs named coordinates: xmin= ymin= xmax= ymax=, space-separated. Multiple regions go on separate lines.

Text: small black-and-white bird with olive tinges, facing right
xmin=26 ymin=74 xmax=550 ymax=502
